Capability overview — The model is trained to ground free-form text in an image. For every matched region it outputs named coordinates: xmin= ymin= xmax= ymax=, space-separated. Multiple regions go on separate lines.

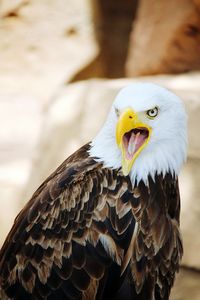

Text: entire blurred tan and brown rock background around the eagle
xmin=0 ymin=0 xmax=200 ymax=300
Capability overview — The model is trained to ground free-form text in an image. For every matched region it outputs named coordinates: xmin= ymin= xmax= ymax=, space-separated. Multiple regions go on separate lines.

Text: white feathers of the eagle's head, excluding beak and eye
xmin=89 ymin=83 xmax=187 ymax=184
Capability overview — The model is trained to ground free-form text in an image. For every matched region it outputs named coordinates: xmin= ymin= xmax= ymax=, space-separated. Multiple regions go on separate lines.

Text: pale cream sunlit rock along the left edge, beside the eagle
xmin=0 ymin=0 xmax=96 ymax=244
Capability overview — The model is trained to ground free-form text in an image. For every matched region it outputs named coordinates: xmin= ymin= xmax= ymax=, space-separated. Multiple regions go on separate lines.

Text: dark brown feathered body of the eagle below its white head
xmin=0 ymin=144 xmax=182 ymax=300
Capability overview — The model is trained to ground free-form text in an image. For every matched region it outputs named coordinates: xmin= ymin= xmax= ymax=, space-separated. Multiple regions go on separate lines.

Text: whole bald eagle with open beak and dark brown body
xmin=0 ymin=83 xmax=187 ymax=300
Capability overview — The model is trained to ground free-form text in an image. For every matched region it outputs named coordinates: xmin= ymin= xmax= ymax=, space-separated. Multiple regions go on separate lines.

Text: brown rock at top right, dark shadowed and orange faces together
xmin=73 ymin=0 xmax=200 ymax=81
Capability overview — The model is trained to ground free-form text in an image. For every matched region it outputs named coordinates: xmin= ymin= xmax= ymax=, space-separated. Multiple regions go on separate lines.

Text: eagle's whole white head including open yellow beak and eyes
xmin=90 ymin=83 xmax=187 ymax=183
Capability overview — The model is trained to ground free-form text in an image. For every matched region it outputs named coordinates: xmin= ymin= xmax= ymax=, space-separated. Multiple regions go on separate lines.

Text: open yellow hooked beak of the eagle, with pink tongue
xmin=116 ymin=108 xmax=152 ymax=176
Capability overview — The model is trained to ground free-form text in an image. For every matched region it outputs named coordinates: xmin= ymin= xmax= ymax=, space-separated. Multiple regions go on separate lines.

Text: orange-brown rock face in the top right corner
xmin=126 ymin=0 xmax=200 ymax=77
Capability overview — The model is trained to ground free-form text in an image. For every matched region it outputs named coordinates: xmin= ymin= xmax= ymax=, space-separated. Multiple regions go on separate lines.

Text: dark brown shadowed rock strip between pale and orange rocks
xmin=71 ymin=0 xmax=138 ymax=82
